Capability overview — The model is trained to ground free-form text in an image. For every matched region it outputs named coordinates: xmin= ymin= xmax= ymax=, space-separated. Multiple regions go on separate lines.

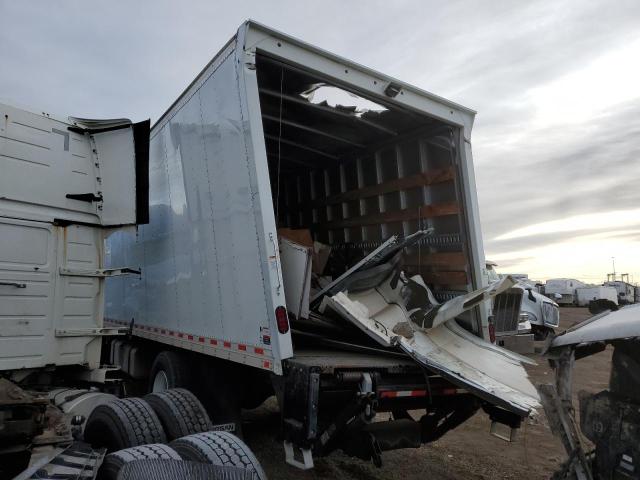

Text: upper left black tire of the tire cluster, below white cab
xmin=84 ymin=398 xmax=167 ymax=452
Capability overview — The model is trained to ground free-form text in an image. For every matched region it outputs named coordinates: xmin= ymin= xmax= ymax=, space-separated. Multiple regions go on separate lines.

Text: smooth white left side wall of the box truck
xmin=107 ymin=45 xmax=290 ymax=370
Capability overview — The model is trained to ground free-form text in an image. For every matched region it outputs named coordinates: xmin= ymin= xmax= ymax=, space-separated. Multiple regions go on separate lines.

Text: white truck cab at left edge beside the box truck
xmin=0 ymin=104 xmax=149 ymax=375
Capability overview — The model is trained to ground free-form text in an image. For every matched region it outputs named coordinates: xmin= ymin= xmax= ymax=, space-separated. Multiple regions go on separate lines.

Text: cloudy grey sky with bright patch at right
xmin=0 ymin=0 xmax=640 ymax=282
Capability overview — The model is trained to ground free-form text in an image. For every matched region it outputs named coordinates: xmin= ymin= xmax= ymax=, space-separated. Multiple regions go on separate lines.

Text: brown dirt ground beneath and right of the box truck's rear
xmin=245 ymin=308 xmax=611 ymax=480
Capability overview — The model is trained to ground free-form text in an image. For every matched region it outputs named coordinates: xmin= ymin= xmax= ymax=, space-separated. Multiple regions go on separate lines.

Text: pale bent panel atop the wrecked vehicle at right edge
xmin=550 ymin=305 xmax=640 ymax=349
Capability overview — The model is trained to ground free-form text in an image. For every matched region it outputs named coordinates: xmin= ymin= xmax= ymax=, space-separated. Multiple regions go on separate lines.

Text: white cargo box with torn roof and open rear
xmin=106 ymin=22 xmax=488 ymax=373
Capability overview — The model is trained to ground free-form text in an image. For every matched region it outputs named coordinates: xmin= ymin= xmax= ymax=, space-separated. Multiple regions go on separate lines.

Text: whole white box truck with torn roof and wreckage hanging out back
xmin=106 ymin=21 xmax=537 ymax=468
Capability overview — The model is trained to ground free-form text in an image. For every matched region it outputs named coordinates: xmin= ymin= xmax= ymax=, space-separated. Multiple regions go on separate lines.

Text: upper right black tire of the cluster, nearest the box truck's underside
xmin=144 ymin=388 xmax=213 ymax=440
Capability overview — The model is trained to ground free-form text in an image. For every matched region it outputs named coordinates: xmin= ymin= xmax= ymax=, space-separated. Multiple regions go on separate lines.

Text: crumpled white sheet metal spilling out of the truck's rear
xmin=324 ymin=277 xmax=540 ymax=416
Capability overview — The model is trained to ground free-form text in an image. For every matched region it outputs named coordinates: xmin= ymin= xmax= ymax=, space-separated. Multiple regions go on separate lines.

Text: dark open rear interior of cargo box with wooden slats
xmin=256 ymin=53 xmax=477 ymax=322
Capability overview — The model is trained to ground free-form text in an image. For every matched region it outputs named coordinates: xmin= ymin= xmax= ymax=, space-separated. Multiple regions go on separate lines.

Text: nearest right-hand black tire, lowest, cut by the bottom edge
xmin=170 ymin=432 xmax=267 ymax=480
